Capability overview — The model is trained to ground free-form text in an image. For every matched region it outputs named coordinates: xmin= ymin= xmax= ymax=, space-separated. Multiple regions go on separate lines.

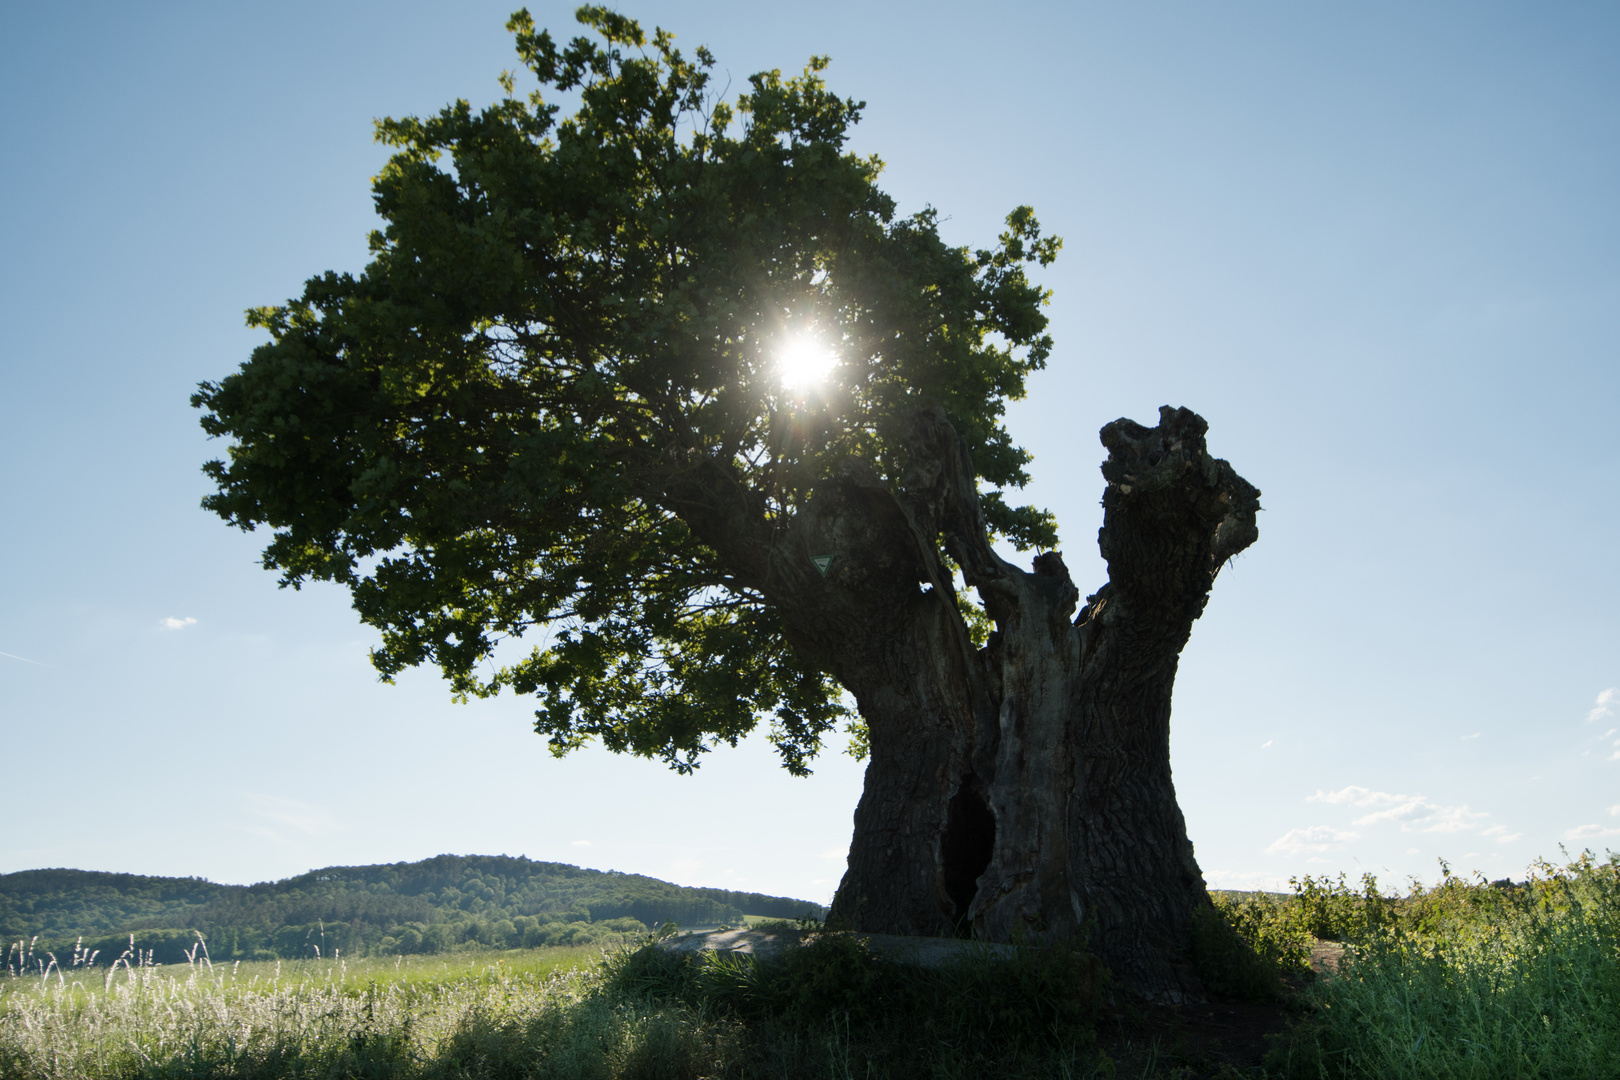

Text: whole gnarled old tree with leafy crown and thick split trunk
xmin=194 ymin=8 xmax=1259 ymax=1001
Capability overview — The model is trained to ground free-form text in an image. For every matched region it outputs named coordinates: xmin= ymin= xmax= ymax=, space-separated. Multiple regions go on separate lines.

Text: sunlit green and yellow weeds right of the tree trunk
xmin=1272 ymin=853 xmax=1620 ymax=1080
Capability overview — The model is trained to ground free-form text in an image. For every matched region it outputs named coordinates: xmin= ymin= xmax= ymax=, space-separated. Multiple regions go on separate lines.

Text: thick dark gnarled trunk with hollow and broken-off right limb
xmin=664 ymin=408 xmax=1259 ymax=1001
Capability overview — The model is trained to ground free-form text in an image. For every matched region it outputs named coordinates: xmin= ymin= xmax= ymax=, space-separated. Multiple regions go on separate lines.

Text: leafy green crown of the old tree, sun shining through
xmin=193 ymin=6 xmax=1058 ymax=772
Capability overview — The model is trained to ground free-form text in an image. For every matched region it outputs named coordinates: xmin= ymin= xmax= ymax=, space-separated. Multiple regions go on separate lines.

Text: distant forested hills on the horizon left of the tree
xmin=0 ymin=855 xmax=825 ymax=965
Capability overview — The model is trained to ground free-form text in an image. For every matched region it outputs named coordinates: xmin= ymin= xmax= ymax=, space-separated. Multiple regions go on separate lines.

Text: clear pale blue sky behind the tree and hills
xmin=0 ymin=2 xmax=1620 ymax=899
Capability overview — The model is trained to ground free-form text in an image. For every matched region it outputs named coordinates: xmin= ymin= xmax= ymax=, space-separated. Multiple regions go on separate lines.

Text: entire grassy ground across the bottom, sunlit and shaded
xmin=0 ymin=857 xmax=1620 ymax=1080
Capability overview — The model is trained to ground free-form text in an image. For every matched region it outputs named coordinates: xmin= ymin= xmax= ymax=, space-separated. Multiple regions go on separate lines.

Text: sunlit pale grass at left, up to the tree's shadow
xmin=0 ymin=949 xmax=606 ymax=1080
